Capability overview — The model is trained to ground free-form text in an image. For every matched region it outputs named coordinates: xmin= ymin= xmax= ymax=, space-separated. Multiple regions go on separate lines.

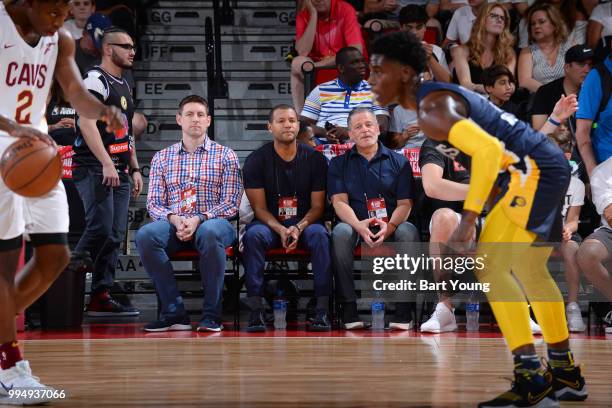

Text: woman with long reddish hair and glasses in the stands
xmin=453 ymin=3 xmax=516 ymax=95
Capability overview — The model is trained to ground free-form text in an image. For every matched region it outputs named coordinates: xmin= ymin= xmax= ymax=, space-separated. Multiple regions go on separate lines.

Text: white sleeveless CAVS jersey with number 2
xmin=0 ymin=2 xmax=58 ymax=137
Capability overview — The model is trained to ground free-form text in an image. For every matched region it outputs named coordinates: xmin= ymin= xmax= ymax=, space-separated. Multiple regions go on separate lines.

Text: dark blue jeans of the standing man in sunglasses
xmin=73 ymin=167 xmax=131 ymax=293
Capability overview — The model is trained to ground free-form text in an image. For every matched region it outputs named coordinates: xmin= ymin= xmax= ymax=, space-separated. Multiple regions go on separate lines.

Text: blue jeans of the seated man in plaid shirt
xmin=136 ymin=218 xmax=236 ymax=322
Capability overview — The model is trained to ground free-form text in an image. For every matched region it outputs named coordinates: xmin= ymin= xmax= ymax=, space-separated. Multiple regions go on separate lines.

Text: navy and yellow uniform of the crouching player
xmin=417 ymin=82 xmax=570 ymax=240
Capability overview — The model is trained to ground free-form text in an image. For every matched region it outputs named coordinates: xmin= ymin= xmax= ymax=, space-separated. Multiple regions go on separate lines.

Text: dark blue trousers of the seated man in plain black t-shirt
xmin=242 ymin=220 xmax=331 ymax=297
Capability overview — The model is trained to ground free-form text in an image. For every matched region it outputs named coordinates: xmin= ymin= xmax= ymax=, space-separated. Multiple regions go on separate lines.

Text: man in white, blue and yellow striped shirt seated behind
xmin=300 ymin=47 xmax=389 ymax=144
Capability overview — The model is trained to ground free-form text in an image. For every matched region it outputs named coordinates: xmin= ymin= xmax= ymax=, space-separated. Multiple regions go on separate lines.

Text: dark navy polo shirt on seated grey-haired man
xmin=327 ymin=142 xmax=414 ymax=220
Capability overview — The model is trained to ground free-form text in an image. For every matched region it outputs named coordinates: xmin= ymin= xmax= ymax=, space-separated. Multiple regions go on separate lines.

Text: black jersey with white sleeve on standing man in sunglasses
xmin=73 ymin=67 xmax=134 ymax=171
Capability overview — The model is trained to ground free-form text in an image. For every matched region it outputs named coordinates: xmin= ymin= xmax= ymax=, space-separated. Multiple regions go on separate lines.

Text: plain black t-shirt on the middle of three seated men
xmin=242 ymin=142 xmax=327 ymax=220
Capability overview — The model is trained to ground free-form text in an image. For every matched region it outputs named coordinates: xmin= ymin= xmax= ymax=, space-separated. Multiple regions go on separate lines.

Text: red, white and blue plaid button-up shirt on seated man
xmin=147 ymin=137 xmax=242 ymax=220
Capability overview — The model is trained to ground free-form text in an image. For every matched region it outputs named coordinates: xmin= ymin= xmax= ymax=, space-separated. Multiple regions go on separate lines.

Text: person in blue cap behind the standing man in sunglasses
xmin=74 ymin=13 xmax=147 ymax=138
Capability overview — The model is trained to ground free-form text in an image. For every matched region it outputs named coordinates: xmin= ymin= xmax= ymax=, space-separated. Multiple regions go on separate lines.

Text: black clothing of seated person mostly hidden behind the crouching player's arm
xmin=419 ymin=139 xmax=470 ymax=216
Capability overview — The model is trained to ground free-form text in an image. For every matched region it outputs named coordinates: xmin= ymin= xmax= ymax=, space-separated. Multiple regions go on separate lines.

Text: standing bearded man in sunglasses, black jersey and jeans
xmin=73 ymin=29 xmax=143 ymax=316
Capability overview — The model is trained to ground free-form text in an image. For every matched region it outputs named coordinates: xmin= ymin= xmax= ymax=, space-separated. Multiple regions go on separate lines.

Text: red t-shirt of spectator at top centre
xmin=296 ymin=0 xmax=366 ymax=61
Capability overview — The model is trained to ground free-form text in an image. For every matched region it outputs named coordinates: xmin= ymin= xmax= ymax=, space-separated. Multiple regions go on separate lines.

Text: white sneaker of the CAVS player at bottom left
xmin=0 ymin=360 xmax=58 ymax=405
